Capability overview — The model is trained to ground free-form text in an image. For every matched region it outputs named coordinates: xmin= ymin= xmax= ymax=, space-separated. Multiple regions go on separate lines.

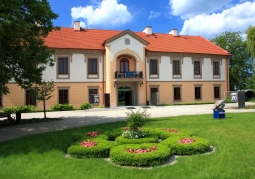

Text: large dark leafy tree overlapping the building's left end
xmin=0 ymin=0 xmax=58 ymax=94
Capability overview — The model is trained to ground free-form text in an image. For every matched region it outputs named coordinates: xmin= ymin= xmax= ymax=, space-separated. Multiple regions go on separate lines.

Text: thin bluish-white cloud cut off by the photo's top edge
xmin=169 ymin=0 xmax=232 ymax=19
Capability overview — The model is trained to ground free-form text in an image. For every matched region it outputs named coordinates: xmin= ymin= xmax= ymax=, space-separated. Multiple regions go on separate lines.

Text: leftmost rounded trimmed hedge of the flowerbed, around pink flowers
xmin=67 ymin=138 xmax=116 ymax=158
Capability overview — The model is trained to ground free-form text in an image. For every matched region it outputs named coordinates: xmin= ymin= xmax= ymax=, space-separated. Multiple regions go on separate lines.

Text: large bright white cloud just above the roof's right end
xmin=180 ymin=2 xmax=255 ymax=38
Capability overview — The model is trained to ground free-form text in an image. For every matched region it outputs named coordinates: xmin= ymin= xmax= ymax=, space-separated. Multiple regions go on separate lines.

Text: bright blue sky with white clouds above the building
xmin=48 ymin=0 xmax=255 ymax=39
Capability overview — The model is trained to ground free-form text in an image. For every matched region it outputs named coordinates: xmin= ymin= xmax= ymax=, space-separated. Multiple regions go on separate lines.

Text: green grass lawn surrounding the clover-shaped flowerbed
xmin=0 ymin=113 xmax=255 ymax=179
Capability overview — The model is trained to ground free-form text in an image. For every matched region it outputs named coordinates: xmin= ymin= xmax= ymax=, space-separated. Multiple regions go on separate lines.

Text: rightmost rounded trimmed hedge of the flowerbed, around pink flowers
xmin=161 ymin=136 xmax=210 ymax=155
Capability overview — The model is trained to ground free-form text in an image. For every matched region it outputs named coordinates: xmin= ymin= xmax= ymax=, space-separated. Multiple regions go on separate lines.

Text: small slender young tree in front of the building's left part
xmin=32 ymin=81 xmax=55 ymax=118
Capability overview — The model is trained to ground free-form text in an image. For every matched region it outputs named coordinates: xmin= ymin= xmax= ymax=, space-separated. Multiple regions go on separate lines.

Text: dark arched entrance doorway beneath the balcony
xmin=118 ymin=86 xmax=132 ymax=106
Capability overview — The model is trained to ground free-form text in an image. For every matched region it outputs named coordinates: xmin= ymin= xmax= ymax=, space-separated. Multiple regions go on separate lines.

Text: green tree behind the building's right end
xmin=211 ymin=32 xmax=254 ymax=90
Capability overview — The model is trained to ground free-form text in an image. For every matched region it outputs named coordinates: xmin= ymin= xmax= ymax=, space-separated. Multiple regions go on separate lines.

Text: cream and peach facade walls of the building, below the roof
xmin=2 ymin=28 xmax=229 ymax=109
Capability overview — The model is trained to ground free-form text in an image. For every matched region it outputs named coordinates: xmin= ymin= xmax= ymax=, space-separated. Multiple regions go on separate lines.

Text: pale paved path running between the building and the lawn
xmin=0 ymin=103 xmax=255 ymax=141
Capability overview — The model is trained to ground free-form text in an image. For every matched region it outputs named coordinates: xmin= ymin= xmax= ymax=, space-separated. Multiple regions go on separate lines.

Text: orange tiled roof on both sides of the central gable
xmin=45 ymin=28 xmax=230 ymax=55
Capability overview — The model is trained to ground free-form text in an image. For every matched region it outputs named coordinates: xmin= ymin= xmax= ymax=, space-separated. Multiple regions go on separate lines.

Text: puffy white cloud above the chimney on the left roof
xmin=71 ymin=0 xmax=133 ymax=26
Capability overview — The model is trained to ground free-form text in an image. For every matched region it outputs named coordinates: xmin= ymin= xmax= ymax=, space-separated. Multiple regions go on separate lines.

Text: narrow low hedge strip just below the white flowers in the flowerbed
xmin=115 ymin=136 xmax=158 ymax=145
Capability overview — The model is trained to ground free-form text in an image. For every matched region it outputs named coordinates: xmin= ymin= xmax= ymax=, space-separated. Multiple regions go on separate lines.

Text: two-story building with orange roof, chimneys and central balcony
xmin=0 ymin=21 xmax=230 ymax=109
